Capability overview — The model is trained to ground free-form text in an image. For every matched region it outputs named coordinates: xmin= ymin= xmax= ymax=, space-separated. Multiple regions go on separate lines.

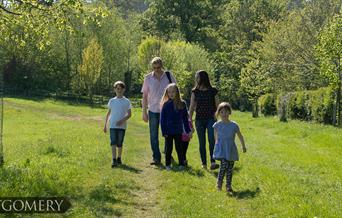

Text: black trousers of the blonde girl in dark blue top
xmin=165 ymin=134 xmax=184 ymax=166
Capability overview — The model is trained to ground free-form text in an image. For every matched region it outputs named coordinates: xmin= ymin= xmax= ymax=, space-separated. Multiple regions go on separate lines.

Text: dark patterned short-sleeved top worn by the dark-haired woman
xmin=192 ymin=88 xmax=218 ymax=120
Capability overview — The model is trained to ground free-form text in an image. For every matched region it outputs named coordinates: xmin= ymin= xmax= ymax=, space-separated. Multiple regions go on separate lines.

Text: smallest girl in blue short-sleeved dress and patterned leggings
xmin=213 ymin=102 xmax=247 ymax=194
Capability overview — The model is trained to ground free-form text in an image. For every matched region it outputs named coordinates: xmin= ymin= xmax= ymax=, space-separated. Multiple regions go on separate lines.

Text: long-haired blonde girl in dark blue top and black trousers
xmin=160 ymin=83 xmax=190 ymax=170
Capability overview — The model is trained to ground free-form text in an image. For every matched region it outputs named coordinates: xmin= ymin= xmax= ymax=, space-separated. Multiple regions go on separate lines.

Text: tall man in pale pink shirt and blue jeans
xmin=141 ymin=57 xmax=176 ymax=165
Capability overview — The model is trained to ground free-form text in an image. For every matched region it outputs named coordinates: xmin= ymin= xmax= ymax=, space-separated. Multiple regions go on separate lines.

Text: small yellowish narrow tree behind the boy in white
xmin=78 ymin=38 xmax=103 ymax=103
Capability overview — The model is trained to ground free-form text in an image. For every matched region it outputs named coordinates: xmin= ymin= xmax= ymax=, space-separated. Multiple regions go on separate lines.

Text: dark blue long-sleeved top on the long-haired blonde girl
xmin=160 ymin=100 xmax=190 ymax=136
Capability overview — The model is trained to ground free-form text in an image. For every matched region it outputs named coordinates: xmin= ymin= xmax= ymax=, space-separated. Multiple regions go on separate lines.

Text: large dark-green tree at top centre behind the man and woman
xmin=141 ymin=0 xmax=227 ymax=50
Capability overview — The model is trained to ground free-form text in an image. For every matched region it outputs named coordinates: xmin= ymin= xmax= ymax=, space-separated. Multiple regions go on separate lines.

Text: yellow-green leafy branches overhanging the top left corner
xmin=0 ymin=0 xmax=106 ymax=50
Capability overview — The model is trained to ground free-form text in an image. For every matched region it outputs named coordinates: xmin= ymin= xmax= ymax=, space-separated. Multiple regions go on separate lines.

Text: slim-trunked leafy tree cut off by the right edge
xmin=316 ymin=13 xmax=342 ymax=125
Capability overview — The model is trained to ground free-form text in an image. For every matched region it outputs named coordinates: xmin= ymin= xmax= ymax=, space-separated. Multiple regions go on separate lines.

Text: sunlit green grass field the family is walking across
xmin=0 ymin=98 xmax=342 ymax=217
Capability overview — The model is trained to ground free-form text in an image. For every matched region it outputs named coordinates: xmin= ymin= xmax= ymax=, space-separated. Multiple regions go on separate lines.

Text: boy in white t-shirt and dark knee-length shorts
xmin=103 ymin=81 xmax=132 ymax=168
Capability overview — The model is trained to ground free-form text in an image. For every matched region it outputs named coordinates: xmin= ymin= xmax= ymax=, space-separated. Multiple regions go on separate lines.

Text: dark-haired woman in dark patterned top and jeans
xmin=189 ymin=70 xmax=219 ymax=170
